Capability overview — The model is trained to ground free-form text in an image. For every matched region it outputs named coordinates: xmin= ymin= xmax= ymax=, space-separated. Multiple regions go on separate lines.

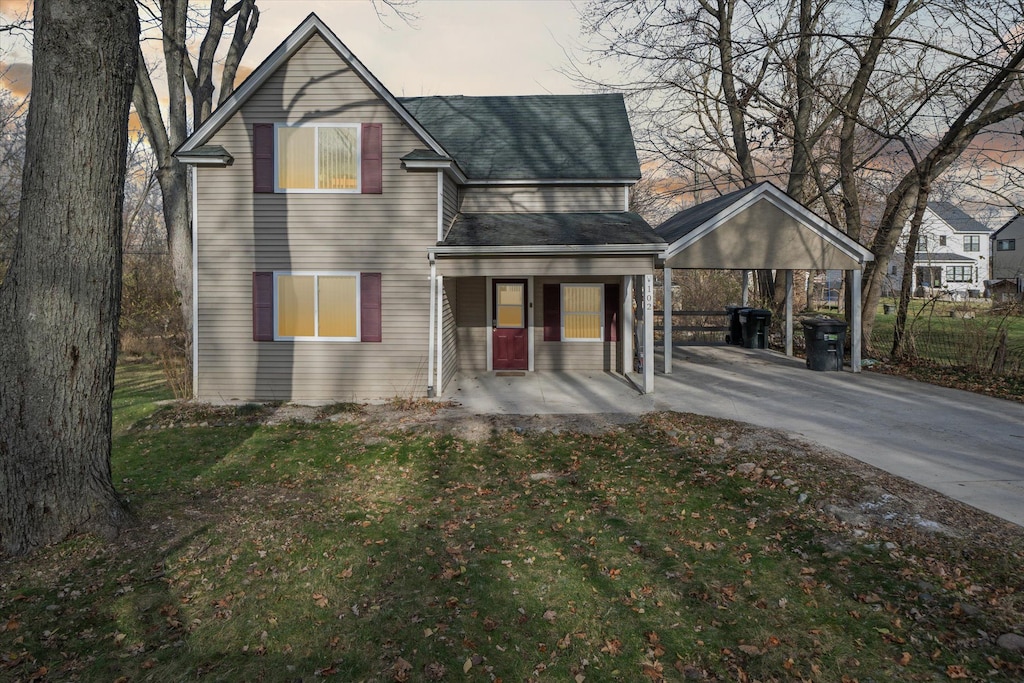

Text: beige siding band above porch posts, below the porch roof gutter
xmin=437 ymin=255 xmax=654 ymax=278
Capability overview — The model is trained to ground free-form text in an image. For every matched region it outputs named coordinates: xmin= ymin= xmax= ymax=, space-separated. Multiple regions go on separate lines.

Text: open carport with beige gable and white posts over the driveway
xmin=655 ymin=182 xmax=873 ymax=374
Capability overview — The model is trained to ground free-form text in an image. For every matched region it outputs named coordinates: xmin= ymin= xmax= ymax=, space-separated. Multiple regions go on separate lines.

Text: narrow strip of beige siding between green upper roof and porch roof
xmin=461 ymin=185 xmax=626 ymax=213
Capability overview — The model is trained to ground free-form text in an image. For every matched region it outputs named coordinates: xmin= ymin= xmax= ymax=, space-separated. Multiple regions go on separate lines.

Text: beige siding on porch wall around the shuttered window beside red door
xmin=534 ymin=278 xmax=622 ymax=372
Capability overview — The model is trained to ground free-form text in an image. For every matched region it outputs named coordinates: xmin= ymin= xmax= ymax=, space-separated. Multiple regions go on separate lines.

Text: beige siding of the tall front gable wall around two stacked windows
xmin=197 ymin=37 xmax=437 ymax=400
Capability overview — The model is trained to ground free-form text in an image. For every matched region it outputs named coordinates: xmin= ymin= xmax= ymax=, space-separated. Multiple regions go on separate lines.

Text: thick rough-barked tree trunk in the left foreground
xmin=0 ymin=0 xmax=139 ymax=554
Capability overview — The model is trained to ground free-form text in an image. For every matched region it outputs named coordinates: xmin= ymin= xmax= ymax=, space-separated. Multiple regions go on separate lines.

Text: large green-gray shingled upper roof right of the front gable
xmin=398 ymin=94 xmax=640 ymax=180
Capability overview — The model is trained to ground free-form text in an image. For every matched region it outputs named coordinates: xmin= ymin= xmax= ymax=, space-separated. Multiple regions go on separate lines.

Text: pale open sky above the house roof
xmin=0 ymin=0 xmax=602 ymax=96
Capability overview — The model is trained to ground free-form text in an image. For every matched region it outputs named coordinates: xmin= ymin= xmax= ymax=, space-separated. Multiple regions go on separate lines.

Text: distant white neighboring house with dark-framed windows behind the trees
xmin=889 ymin=202 xmax=991 ymax=299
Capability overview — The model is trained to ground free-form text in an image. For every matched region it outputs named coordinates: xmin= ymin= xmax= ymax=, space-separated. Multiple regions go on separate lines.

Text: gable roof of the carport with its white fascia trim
xmin=654 ymin=181 xmax=874 ymax=268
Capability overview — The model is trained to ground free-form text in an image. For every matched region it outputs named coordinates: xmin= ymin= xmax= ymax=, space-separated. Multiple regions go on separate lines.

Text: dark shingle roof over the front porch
xmin=441 ymin=213 xmax=665 ymax=247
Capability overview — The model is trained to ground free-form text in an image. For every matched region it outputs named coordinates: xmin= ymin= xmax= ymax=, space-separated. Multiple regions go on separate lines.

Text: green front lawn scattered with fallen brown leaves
xmin=0 ymin=365 xmax=1024 ymax=681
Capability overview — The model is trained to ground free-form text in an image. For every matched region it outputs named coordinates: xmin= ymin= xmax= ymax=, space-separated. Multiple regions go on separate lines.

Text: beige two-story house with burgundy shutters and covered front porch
xmin=176 ymin=14 xmax=666 ymax=401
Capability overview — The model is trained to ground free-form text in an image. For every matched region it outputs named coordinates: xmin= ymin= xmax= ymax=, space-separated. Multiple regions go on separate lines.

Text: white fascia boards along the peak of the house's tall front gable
xmin=177 ymin=14 xmax=449 ymax=157
